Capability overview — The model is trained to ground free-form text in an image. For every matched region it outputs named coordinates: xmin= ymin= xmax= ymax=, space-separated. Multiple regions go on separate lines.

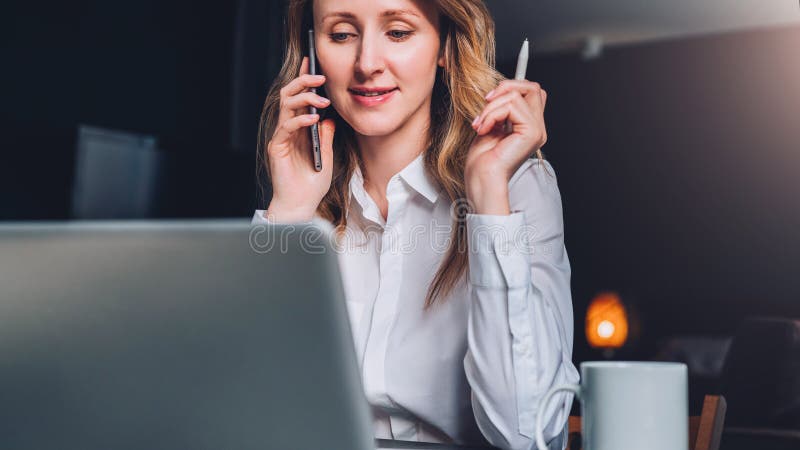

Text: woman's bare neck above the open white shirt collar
xmin=356 ymin=105 xmax=430 ymax=202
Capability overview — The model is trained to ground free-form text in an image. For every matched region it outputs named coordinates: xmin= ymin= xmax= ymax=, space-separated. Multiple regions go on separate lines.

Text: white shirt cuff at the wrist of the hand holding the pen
xmin=467 ymin=211 xmax=533 ymax=288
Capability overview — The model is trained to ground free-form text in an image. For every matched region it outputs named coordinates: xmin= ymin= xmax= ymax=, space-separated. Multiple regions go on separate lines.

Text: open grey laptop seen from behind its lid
xmin=0 ymin=220 xmax=376 ymax=450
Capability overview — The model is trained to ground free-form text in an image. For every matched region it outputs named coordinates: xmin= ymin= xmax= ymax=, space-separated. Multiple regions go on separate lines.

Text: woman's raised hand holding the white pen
xmin=464 ymin=80 xmax=547 ymax=215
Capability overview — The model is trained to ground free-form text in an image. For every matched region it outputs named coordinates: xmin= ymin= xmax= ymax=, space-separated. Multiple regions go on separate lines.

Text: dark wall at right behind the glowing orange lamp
xmin=499 ymin=27 xmax=800 ymax=359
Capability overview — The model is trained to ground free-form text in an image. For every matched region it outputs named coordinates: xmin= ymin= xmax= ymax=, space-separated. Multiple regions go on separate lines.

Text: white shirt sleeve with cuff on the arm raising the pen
xmin=464 ymin=159 xmax=578 ymax=449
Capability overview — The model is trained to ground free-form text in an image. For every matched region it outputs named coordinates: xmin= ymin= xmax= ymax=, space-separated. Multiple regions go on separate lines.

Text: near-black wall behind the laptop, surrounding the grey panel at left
xmin=0 ymin=0 xmax=255 ymax=219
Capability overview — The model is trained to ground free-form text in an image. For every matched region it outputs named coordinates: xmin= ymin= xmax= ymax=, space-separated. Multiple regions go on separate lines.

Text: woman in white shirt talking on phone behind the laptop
xmin=254 ymin=0 xmax=578 ymax=449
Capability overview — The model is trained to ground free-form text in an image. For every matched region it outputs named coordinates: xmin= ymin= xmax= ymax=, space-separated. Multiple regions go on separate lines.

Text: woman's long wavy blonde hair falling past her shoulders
xmin=257 ymin=0 xmax=541 ymax=309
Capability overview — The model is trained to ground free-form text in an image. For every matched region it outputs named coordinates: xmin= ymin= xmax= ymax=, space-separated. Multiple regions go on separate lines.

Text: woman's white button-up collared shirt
xmin=253 ymin=155 xmax=578 ymax=449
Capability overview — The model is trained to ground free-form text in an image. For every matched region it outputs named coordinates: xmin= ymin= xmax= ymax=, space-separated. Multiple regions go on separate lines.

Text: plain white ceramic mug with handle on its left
xmin=536 ymin=361 xmax=689 ymax=450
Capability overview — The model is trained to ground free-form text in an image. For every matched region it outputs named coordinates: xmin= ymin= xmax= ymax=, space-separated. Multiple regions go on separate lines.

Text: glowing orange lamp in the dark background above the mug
xmin=586 ymin=292 xmax=628 ymax=349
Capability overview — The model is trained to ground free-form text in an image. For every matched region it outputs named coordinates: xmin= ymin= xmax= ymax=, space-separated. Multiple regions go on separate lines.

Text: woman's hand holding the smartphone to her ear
xmin=266 ymin=57 xmax=336 ymax=222
